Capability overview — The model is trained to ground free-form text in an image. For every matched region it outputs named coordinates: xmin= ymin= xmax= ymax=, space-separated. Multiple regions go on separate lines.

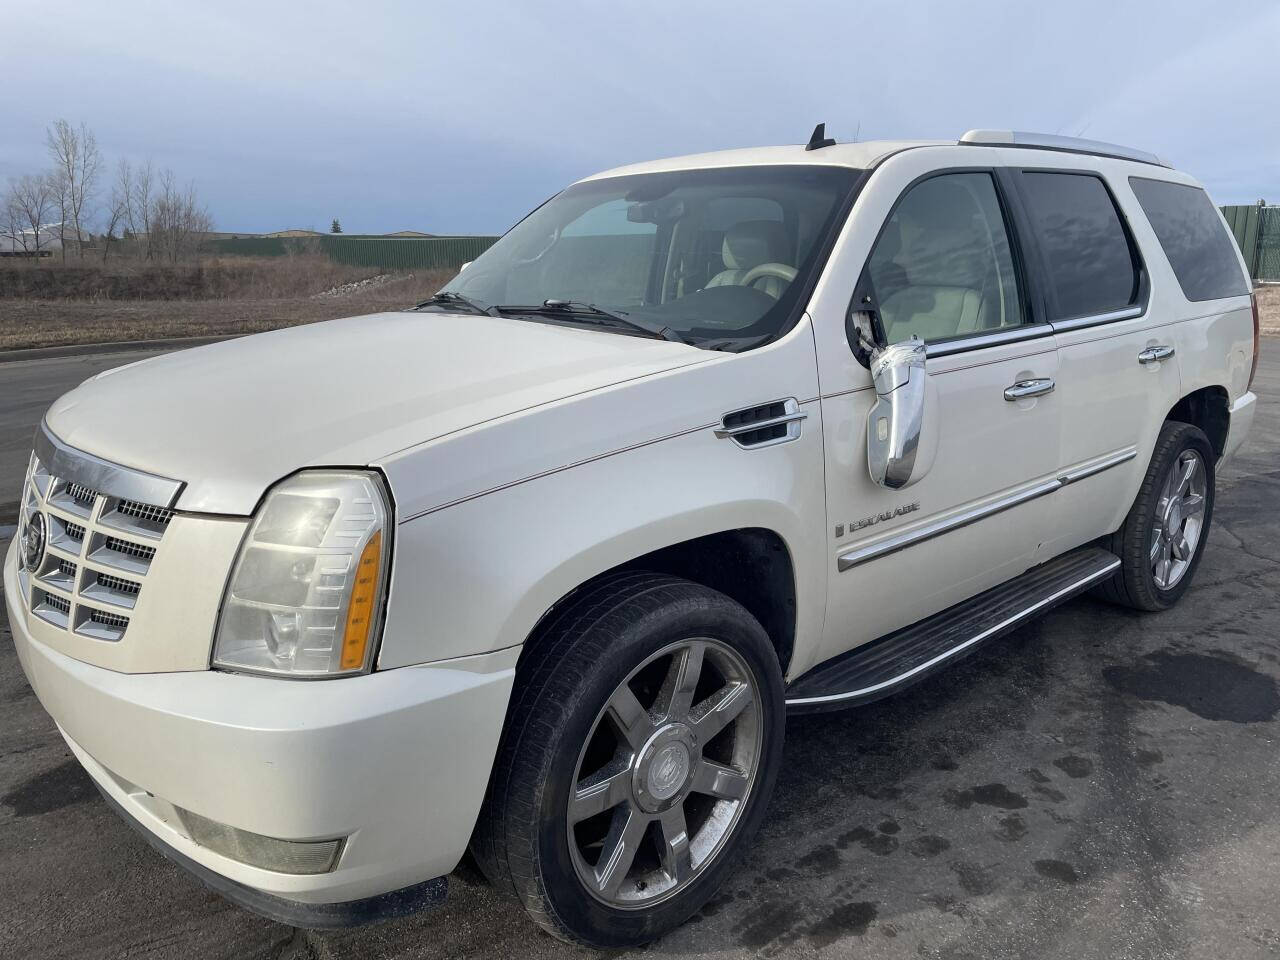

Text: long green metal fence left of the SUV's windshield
xmin=209 ymin=236 xmax=498 ymax=270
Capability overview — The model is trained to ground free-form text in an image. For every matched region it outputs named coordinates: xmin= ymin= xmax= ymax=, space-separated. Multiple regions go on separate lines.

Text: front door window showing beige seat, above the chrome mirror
xmin=867 ymin=173 xmax=1025 ymax=343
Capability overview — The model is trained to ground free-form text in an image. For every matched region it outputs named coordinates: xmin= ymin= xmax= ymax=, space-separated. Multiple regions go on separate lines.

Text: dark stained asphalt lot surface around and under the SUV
xmin=0 ymin=340 xmax=1280 ymax=960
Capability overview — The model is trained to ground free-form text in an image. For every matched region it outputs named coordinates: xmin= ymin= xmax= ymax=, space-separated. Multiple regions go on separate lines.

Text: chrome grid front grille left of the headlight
xmin=19 ymin=447 xmax=183 ymax=643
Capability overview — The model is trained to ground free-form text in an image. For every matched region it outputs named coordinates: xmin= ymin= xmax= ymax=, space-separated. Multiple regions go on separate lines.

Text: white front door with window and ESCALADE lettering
xmin=814 ymin=163 xmax=1061 ymax=662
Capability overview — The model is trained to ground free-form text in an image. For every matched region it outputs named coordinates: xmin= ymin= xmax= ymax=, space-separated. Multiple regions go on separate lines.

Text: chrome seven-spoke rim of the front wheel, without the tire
xmin=567 ymin=637 xmax=764 ymax=909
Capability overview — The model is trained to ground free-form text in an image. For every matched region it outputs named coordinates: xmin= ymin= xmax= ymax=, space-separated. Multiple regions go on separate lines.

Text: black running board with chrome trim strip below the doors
xmin=786 ymin=547 xmax=1120 ymax=713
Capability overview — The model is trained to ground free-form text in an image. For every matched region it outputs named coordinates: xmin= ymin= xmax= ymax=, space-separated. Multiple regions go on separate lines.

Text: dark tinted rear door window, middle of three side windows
xmin=1023 ymin=172 xmax=1140 ymax=320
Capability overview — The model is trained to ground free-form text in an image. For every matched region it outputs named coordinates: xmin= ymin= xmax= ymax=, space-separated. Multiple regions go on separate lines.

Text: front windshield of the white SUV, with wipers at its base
xmin=442 ymin=165 xmax=860 ymax=349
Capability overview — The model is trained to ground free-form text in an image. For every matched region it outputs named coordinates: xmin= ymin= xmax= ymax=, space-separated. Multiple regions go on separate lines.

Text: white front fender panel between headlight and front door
xmin=378 ymin=402 xmax=827 ymax=668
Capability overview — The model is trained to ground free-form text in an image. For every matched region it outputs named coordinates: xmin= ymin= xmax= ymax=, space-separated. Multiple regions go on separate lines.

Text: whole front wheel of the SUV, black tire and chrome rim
xmin=472 ymin=572 xmax=785 ymax=947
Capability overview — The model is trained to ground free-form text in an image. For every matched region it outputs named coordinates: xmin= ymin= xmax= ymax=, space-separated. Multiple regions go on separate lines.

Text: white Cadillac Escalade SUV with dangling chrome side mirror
xmin=4 ymin=129 xmax=1258 ymax=946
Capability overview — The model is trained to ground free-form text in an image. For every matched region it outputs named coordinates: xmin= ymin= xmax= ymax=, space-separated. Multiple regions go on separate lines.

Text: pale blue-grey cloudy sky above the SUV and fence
xmin=0 ymin=0 xmax=1280 ymax=234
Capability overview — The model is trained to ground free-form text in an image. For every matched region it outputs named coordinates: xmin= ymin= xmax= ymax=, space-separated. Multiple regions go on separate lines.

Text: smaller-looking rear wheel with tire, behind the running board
xmin=1096 ymin=420 xmax=1216 ymax=611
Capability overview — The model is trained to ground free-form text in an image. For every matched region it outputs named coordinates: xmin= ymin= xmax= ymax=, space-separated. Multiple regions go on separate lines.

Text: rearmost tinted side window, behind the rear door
xmin=1129 ymin=177 xmax=1249 ymax=301
